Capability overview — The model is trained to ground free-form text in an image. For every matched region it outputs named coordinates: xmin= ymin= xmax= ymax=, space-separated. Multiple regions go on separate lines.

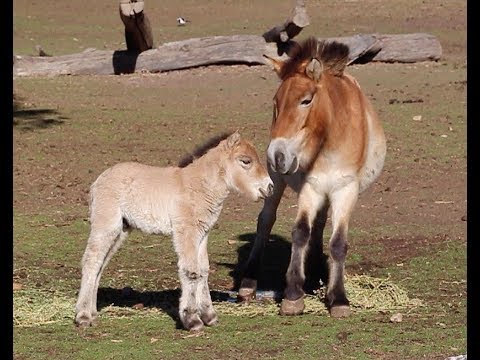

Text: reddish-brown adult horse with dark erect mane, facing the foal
xmin=238 ymin=38 xmax=386 ymax=317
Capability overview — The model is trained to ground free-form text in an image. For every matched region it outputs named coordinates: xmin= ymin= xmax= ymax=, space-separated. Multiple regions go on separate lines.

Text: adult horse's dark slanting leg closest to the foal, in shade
xmin=238 ymin=173 xmax=286 ymax=302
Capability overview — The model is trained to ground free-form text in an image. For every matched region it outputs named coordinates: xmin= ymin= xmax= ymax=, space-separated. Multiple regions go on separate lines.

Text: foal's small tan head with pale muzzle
xmin=223 ymin=132 xmax=273 ymax=201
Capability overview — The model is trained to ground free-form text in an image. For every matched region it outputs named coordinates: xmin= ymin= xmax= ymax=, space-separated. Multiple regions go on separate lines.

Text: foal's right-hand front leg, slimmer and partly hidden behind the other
xmin=197 ymin=236 xmax=218 ymax=326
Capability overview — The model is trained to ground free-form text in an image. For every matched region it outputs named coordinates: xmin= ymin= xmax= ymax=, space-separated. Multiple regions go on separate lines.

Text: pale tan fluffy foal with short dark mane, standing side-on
xmin=75 ymin=132 xmax=273 ymax=330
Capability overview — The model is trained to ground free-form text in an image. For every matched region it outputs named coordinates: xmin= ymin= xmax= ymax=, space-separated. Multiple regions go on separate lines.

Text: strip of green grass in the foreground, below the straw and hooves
xmin=14 ymin=308 xmax=466 ymax=359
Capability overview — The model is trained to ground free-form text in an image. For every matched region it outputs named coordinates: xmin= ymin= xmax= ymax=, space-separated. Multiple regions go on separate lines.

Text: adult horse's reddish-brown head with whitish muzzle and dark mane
xmin=265 ymin=38 xmax=349 ymax=174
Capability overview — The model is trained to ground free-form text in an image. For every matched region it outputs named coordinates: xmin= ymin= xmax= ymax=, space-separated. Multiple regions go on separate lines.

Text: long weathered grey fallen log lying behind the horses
xmin=13 ymin=33 xmax=442 ymax=76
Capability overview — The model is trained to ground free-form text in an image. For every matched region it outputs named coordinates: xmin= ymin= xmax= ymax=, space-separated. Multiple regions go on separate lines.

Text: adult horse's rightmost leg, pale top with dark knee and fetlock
xmin=326 ymin=182 xmax=358 ymax=317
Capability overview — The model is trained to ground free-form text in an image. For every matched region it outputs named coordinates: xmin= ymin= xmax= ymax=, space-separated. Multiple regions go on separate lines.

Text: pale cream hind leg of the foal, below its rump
xmin=75 ymin=222 xmax=122 ymax=326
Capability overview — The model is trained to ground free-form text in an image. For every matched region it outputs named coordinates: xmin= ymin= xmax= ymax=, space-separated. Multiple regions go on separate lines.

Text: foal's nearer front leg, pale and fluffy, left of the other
xmin=174 ymin=229 xmax=203 ymax=331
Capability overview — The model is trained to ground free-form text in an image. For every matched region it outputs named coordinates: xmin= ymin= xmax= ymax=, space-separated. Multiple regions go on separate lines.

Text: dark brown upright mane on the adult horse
xmin=280 ymin=36 xmax=350 ymax=79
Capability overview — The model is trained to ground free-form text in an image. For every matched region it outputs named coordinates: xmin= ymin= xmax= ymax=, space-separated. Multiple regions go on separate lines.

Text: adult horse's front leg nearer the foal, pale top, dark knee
xmin=280 ymin=183 xmax=325 ymax=315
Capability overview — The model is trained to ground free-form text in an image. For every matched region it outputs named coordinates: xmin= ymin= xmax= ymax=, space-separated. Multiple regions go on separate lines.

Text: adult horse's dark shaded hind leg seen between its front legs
xmin=304 ymin=201 xmax=330 ymax=294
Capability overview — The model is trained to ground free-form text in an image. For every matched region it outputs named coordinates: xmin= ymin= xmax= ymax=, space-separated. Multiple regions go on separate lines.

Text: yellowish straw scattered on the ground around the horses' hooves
xmin=13 ymin=275 xmax=422 ymax=327
